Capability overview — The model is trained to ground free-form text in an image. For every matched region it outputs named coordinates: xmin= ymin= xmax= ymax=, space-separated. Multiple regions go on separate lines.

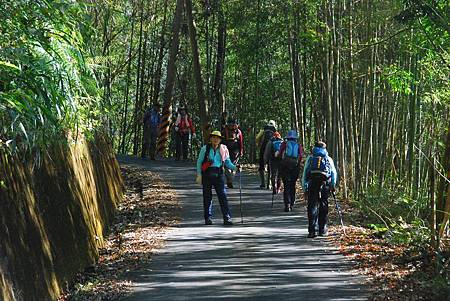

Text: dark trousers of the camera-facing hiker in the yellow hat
xmin=202 ymin=172 xmax=231 ymax=220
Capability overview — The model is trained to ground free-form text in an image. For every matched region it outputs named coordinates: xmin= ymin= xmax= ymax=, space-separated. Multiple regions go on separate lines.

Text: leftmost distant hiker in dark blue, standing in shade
xmin=141 ymin=103 xmax=161 ymax=160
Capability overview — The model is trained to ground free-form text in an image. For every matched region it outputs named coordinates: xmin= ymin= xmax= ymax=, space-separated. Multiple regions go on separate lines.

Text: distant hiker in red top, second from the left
xmin=175 ymin=108 xmax=195 ymax=161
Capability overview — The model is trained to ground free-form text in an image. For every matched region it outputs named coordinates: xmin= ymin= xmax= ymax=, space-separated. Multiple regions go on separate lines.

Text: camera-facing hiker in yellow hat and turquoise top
xmin=197 ymin=131 xmax=240 ymax=226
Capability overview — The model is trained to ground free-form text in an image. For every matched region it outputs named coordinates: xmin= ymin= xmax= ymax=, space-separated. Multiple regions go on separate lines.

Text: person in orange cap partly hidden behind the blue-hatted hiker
xmin=264 ymin=132 xmax=283 ymax=194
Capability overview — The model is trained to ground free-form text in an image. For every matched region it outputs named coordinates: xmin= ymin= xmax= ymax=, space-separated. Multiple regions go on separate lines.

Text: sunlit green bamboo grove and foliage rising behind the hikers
xmin=0 ymin=0 xmax=450 ymax=262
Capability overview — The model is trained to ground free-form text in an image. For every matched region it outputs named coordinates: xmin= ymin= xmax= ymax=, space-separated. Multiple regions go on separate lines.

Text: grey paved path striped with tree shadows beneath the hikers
xmin=119 ymin=157 xmax=367 ymax=301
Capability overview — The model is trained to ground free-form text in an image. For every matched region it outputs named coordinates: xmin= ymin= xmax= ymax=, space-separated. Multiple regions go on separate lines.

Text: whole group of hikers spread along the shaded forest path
xmin=142 ymin=105 xmax=337 ymax=238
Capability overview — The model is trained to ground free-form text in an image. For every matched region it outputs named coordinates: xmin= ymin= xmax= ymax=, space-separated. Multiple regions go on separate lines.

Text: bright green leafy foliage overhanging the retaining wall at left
xmin=0 ymin=0 xmax=102 ymax=155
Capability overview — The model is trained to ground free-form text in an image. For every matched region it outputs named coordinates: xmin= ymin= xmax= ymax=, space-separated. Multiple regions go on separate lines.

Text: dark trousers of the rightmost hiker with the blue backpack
xmin=308 ymin=185 xmax=330 ymax=233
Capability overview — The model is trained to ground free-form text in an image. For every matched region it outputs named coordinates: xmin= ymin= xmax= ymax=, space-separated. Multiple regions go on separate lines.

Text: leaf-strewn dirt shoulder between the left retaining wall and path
xmin=59 ymin=165 xmax=181 ymax=301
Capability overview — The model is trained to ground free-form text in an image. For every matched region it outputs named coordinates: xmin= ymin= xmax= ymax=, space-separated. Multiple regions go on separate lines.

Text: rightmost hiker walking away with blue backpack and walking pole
xmin=302 ymin=141 xmax=337 ymax=238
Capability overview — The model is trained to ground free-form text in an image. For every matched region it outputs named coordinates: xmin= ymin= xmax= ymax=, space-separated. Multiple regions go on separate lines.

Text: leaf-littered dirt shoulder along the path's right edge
xmin=329 ymin=198 xmax=450 ymax=301
